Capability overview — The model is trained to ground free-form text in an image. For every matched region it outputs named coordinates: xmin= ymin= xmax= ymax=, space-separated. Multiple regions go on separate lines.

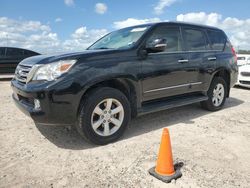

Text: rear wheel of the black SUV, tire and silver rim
xmin=201 ymin=77 xmax=228 ymax=111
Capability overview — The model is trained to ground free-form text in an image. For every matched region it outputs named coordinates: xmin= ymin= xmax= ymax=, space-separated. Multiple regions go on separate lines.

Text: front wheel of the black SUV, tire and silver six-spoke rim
xmin=76 ymin=87 xmax=131 ymax=145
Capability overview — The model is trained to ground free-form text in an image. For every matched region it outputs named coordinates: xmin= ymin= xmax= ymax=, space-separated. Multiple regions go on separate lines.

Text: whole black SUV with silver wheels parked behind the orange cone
xmin=11 ymin=22 xmax=238 ymax=144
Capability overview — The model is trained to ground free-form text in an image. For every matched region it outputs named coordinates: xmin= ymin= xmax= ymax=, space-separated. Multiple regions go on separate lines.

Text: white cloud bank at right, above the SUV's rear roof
xmin=176 ymin=12 xmax=250 ymax=50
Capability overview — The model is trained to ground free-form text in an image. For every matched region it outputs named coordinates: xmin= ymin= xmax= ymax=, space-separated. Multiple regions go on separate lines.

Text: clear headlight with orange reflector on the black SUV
xmin=32 ymin=60 xmax=76 ymax=81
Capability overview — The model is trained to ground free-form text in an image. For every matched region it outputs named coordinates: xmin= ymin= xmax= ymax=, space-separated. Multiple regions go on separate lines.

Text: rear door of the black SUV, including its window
xmin=182 ymin=26 xmax=216 ymax=92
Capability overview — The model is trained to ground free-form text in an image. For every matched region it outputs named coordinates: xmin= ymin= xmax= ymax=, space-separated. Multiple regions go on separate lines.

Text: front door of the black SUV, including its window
xmin=142 ymin=25 xmax=200 ymax=101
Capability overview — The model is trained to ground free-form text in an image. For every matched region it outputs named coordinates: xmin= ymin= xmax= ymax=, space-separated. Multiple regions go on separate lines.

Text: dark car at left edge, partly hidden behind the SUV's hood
xmin=0 ymin=47 xmax=40 ymax=74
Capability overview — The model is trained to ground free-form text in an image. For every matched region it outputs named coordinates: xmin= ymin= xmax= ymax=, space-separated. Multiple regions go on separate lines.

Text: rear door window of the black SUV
xmin=183 ymin=28 xmax=207 ymax=51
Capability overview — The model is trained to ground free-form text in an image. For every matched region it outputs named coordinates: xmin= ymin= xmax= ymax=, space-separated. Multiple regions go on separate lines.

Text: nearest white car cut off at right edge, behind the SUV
xmin=236 ymin=64 xmax=250 ymax=88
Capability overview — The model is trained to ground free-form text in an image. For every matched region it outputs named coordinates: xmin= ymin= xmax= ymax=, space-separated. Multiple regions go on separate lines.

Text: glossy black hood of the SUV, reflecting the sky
xmin=20 ymin=49 xmax=118 ymax=66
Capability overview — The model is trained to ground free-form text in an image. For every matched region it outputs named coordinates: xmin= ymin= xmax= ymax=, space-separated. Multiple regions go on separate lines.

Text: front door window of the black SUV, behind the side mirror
xmin=147 ymin=26 xmax=182 ymax=52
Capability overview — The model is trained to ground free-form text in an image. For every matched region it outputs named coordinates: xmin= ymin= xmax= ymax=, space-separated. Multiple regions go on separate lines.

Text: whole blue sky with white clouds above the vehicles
xmin=0 ymin=0 xmax=250 ymax=53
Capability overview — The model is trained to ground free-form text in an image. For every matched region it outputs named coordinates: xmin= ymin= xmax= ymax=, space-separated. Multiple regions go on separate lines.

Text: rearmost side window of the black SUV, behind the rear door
xmin=207 ymin=30 xmax=226 ymax=50
